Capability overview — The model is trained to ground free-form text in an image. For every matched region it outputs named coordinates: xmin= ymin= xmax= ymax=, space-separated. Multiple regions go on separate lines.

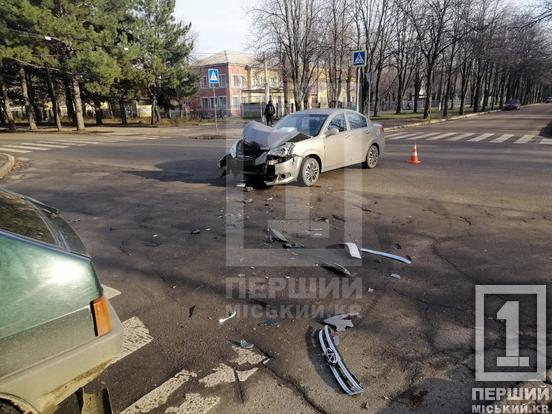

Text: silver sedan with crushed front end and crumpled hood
xmin=219 ymin=109 xmax=385 ymax=186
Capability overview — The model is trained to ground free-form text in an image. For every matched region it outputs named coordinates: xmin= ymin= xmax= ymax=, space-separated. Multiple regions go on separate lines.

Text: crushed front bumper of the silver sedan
xmin=219 ymin=152 xmax=302 ymax=185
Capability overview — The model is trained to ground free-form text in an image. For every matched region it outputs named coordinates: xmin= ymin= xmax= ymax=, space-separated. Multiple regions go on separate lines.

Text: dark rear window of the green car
xmin=0 ymin=192 xmax=56 ymax=244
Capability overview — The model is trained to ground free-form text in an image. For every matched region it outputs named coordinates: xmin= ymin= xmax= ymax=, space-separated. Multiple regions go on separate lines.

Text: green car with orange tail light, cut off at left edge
xmin=0 ymin=190 xmax=123 ymax=414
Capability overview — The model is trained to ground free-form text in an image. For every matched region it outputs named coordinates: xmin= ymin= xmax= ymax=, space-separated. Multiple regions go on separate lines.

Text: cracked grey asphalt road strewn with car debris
xmin=0 ymin=105 xmax=552 ymax=413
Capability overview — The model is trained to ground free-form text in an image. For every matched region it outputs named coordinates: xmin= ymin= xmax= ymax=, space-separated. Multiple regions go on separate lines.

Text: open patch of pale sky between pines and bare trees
xmin=174 ymin=0 xmax=248 ymax=58
